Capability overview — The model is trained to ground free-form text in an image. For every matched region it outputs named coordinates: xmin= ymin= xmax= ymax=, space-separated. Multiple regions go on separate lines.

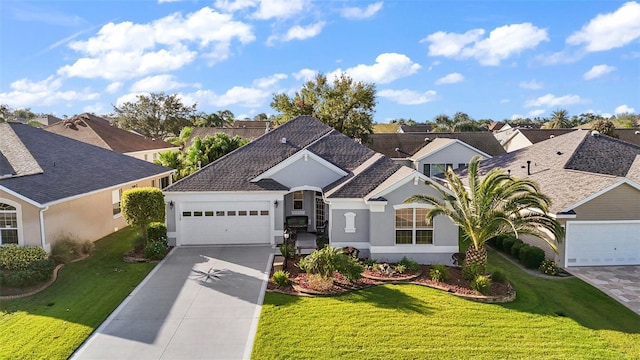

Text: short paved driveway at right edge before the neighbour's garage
xmin=567 ymin=266 xmax=640 ymax=315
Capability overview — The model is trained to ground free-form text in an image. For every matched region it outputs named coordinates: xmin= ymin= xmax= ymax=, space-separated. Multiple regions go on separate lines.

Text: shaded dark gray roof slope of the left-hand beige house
xmin=0 ymin=123 xmax=172 ymax=204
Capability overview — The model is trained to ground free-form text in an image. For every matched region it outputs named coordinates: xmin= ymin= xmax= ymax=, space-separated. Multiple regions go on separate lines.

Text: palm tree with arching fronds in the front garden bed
xmin=405 ymin=156 xmax=564 ymax=269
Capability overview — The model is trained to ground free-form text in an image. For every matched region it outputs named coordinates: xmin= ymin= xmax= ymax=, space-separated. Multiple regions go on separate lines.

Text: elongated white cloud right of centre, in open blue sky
xmin=420 ymin=23 xmax=549 ymax=66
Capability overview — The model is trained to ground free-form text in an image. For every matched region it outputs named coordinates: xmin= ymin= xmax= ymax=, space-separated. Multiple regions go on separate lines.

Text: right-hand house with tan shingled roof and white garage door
xmin=470 ymin=130 xmax=640 ymax=267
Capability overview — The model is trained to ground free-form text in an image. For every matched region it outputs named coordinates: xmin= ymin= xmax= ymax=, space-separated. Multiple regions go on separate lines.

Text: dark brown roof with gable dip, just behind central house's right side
xmin=366 ymin=131 xmax=505 ymax=158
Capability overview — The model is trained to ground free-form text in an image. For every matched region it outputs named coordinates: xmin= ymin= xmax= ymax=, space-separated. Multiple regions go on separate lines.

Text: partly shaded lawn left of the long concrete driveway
xmin=0 ymin=228 xmax=155 ymax=359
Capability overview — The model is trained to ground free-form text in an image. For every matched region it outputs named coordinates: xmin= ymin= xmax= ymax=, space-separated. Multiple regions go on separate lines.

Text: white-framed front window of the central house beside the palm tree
xmin=396 ymin=208 xmax=433 ymax=245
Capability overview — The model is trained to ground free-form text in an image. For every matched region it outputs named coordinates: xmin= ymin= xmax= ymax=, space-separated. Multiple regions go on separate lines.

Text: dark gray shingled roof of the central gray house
xmin=165 ymin=116 xmax=410 ymax=197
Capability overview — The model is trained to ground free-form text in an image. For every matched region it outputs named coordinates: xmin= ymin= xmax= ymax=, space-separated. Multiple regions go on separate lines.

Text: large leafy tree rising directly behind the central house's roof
xmin=271 ymin=74 xmax=376 ymax=142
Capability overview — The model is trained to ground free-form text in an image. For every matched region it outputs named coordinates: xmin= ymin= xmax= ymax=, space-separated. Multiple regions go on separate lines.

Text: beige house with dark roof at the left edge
xmin=0 ymin=123 xmax=173 ymax=251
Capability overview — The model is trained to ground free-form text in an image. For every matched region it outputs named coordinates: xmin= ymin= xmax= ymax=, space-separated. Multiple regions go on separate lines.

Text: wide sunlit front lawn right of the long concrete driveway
xmin=253 ymin=251 xmax=640 ymax=359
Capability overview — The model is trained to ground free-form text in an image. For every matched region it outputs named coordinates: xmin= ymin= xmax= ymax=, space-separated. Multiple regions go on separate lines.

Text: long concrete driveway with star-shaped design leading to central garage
xmin=72 ymin=246 xmax=274 ymax=360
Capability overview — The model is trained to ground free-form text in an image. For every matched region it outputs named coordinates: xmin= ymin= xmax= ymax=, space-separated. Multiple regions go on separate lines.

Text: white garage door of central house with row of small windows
xmin=180 ymin=201 xmax=271 ymax=245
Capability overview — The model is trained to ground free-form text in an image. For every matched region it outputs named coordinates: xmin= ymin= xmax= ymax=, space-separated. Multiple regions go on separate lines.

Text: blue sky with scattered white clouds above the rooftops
xmin=0 ymin=0 xmax=640 ymax=123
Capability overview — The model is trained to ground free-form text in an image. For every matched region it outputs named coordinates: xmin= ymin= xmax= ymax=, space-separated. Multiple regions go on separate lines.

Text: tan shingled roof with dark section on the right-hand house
xmin=460 ymin=130 xmax=640 ymax=213
